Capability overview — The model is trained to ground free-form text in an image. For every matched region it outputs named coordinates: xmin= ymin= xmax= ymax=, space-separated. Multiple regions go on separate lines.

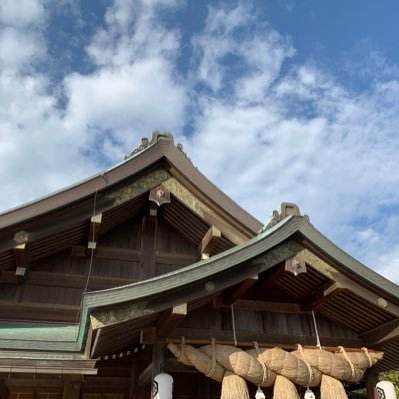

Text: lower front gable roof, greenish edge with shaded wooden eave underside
xmin=2 ymin=216 xmax=399 ymax=369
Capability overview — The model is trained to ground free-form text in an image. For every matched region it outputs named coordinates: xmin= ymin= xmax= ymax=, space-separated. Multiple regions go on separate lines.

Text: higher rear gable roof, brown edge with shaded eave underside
xmin=0 ymin=140 xmax=261 ymax=271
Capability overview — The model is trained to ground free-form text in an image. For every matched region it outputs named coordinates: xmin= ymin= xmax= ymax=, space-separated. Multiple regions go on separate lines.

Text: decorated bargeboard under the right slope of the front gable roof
xmin=297 ymin=249 xmax=399 ymax=317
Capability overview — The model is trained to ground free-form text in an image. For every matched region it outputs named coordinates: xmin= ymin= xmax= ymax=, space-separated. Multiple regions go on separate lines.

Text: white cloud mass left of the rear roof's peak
xmin=0 ymin=1 xmax=186 ymax=209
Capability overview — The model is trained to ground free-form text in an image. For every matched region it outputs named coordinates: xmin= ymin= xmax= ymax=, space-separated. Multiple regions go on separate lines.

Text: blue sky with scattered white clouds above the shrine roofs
xmin=0 ymin=0 xmax=399 ymax=281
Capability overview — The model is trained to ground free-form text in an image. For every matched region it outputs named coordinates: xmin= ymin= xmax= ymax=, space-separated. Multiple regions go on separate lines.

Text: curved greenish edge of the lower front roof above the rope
xmin=1 ymin=216 xmax=399 ymax=351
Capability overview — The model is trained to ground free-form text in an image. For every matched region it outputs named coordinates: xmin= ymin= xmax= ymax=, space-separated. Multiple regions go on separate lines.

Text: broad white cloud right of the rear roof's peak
xmin=189 ymin=4 xmax=399 ymax=282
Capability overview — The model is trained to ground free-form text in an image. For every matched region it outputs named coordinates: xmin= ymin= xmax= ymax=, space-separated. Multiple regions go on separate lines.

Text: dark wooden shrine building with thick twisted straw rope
xmin=0 ymin=132 xmax=399 ymax=399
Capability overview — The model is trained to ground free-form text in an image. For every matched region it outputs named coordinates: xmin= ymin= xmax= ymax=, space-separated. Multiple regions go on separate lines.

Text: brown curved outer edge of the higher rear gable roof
xmin=0 ymin=139 xmax=262 ymax=234
